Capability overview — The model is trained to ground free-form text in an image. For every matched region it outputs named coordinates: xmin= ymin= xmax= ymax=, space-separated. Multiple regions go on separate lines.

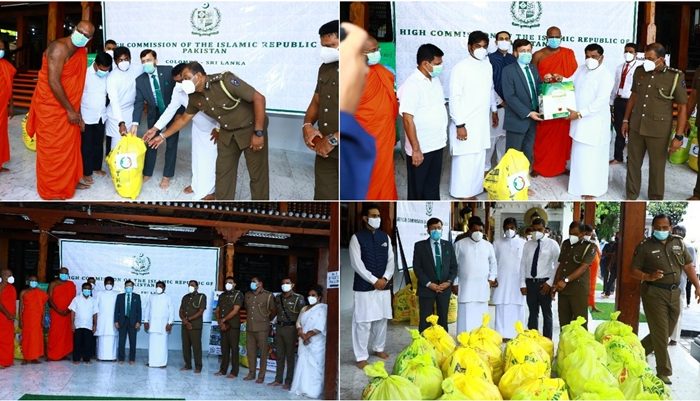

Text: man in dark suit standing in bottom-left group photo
xmin=114 ymin=280 xmax=141 ymax=365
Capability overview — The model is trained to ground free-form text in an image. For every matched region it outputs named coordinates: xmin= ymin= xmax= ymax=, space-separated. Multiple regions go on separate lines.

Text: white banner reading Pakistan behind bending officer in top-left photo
xmin=102 ymin=1 xmax=340 ymax=113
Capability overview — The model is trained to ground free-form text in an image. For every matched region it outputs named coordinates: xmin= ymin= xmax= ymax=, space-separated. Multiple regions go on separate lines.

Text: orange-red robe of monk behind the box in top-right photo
xmin=532 ymin=47 xmax=578 ymax=177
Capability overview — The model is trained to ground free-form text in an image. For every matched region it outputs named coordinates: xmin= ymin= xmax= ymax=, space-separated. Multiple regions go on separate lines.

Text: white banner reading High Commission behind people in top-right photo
xmin=394 ymin=1 xmax=637 ymax=96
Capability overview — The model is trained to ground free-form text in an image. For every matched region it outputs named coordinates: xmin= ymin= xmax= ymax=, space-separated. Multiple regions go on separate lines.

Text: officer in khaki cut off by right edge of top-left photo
xmin=302 ymin=20 xmax=340 ymax=200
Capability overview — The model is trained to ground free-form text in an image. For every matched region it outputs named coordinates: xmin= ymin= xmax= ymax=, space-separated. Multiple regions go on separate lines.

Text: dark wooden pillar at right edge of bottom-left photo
xmin=323 ymin=202 xmax=340 ymax=400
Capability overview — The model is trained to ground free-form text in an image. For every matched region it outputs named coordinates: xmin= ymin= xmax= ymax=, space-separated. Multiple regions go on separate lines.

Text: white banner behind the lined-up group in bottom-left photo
xmin=59 ymin=239 xmax=219 ymax=322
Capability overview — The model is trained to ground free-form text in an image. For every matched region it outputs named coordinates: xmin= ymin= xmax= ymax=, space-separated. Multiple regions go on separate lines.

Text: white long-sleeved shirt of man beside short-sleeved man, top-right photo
xmin=450 ymin=55 xmax=496 ymax=156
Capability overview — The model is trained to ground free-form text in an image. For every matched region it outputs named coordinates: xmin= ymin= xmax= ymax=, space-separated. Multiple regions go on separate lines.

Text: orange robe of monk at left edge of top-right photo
xmin=355 ymin=64 xmax=399 ymax=200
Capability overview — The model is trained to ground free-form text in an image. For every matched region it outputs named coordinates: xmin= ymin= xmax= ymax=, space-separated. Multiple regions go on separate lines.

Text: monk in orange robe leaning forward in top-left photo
xmin=27 ymin=21 xmax=95 ymax=199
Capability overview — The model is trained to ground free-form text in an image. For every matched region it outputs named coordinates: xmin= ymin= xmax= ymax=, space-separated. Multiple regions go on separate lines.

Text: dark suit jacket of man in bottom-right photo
xmin=413 ymin=239 xmax=458 ymax=297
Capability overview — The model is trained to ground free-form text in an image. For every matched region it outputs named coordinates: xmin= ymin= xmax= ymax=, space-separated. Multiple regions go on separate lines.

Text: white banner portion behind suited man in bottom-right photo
xmin=396 ymin=202 xmax=452 ymax=269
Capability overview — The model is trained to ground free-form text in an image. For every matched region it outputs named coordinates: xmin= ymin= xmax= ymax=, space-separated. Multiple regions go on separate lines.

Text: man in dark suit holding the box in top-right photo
xmin=501 ymin=39 xmax=542 ymax=165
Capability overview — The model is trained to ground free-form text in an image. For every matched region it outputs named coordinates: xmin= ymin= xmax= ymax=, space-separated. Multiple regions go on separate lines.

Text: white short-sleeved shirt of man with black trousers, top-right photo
xmin=398 ymin=69 xmax=448 ymax=156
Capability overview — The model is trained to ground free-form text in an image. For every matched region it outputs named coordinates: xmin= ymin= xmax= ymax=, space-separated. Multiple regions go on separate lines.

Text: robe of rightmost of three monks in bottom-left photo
xmin=46 ymin=282 xmax=76 ymax=361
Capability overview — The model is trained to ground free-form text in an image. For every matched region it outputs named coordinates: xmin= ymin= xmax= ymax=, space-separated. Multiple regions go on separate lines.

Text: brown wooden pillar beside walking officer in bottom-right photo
xmin=615 ymin=202 xmax=646 ymax=333
